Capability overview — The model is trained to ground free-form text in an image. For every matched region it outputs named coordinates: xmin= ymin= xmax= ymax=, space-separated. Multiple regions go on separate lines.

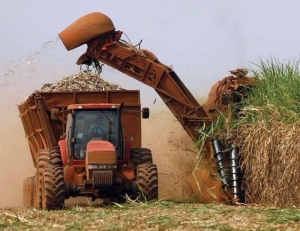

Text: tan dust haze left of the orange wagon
xmin=0 ymin=105 xmax=34 ymax=208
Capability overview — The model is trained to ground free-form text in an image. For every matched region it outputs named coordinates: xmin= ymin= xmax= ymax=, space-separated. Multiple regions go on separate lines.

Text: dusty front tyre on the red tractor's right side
xmin=136 ymin=164 xmax=158 ymax=201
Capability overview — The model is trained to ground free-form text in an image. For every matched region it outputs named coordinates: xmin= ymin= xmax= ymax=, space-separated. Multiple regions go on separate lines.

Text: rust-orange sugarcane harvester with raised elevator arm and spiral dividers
xmin=59 ymin=12 xmax=253 ymax=202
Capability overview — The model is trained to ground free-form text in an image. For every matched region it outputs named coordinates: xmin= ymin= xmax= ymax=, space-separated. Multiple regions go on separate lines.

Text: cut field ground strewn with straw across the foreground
xmin=0 ymin=201 xmax=300 ymax=230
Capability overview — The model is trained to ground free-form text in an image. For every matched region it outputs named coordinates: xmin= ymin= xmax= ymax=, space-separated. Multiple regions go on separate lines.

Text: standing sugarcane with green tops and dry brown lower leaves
xmin=228 ymin=59 xmax=300 ymax=205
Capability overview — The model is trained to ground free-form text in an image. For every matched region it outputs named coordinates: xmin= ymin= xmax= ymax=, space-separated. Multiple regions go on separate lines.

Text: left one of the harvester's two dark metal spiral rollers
xmin=211 ymin=139 xmax=229 ymax=189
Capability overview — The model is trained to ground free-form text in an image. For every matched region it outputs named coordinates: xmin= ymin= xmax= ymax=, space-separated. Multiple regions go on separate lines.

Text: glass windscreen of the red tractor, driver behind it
xmin=73 ymin=109 xmax=118 ymax=159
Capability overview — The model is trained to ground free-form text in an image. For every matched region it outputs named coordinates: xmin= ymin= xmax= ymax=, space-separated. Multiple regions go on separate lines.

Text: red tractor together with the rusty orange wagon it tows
xmin=18 ymin=90 xmax=158 ymax=210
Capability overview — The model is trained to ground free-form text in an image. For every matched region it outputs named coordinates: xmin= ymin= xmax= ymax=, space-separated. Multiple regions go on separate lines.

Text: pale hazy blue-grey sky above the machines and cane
xmin=0 ymin=0 xmax=300 ymax=106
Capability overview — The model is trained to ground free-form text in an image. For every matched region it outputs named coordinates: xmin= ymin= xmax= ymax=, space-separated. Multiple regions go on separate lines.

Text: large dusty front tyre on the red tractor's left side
xmin=42 ymin=166 xmax=65 ymax=210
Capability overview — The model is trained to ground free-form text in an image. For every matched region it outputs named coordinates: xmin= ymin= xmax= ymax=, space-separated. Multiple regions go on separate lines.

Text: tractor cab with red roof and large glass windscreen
xmin=66 ymin=104 xmax=123 ymax=160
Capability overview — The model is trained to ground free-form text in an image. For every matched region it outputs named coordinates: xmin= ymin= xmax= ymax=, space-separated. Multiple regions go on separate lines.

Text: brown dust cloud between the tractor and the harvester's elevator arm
xmin=142 ymin=110 xmax=197 ymax=201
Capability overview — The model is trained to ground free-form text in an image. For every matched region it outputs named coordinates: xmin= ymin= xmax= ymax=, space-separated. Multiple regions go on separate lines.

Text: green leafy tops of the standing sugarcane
xmin=236 ymin=59 xmax=300 ymax=123
